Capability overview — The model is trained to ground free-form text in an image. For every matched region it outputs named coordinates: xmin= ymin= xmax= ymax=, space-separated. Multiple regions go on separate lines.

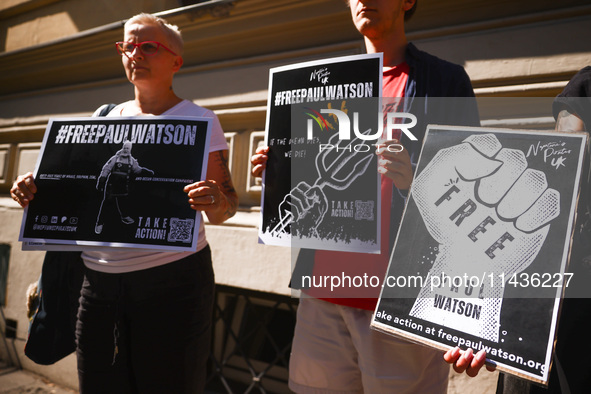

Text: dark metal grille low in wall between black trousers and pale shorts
xmin=206 ymin=285 xmax=298 ymax=394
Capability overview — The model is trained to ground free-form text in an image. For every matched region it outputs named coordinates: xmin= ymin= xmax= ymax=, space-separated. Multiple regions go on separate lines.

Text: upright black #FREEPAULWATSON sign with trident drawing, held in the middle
xmin=259 ymin=54 xmax=382 ymax=252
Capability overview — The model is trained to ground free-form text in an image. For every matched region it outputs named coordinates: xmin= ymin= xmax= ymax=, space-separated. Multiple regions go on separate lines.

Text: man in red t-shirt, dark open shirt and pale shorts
xmin=251 ymin=0 xmax=478 ymax=393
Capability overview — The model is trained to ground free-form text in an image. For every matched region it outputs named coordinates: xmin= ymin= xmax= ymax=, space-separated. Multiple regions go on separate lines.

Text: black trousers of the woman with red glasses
xmin=76 ymin=247 xmax=215 ymax=393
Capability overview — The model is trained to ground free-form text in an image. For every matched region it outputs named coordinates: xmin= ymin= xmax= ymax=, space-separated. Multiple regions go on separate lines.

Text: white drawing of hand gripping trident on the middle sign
xmin=271 ymin=129 xmax=375 ymax=237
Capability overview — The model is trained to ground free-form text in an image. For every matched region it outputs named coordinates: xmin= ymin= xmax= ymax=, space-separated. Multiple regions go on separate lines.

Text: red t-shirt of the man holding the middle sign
xmin=304 ymin=63 xmax=409 ymax=310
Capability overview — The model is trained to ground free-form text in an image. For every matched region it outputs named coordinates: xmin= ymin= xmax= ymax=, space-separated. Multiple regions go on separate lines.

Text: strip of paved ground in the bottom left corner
xmin=0 ymin=367 xmax=77 ymax=394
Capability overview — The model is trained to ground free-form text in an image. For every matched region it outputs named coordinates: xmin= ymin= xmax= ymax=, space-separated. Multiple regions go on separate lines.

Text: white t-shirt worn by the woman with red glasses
xmin=82 ymin=100 xmax=228 ymax=273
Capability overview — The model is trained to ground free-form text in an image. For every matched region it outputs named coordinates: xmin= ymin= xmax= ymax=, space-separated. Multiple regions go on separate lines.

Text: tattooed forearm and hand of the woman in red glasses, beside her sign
xmin=184 ymin=149 xmax=238 ymax=224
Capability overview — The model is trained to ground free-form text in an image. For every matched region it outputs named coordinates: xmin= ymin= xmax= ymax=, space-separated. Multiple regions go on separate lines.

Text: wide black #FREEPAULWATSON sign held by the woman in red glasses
xmin=20 ymin=116 xmax=211 ymax=251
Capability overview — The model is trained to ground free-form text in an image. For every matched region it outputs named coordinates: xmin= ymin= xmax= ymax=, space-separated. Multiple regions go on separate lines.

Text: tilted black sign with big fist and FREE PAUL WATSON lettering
xmin=372 ymin=126 xmax=587 ymax=383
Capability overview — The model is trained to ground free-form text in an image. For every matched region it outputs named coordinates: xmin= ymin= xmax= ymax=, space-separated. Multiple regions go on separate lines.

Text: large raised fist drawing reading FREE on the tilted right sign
xmin=410 ymin=134 xmax=560 ymax=342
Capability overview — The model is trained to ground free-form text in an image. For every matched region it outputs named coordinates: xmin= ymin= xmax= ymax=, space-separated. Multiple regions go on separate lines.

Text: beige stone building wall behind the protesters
xmin=0 ymin=0 xmax=591 ymax=387
